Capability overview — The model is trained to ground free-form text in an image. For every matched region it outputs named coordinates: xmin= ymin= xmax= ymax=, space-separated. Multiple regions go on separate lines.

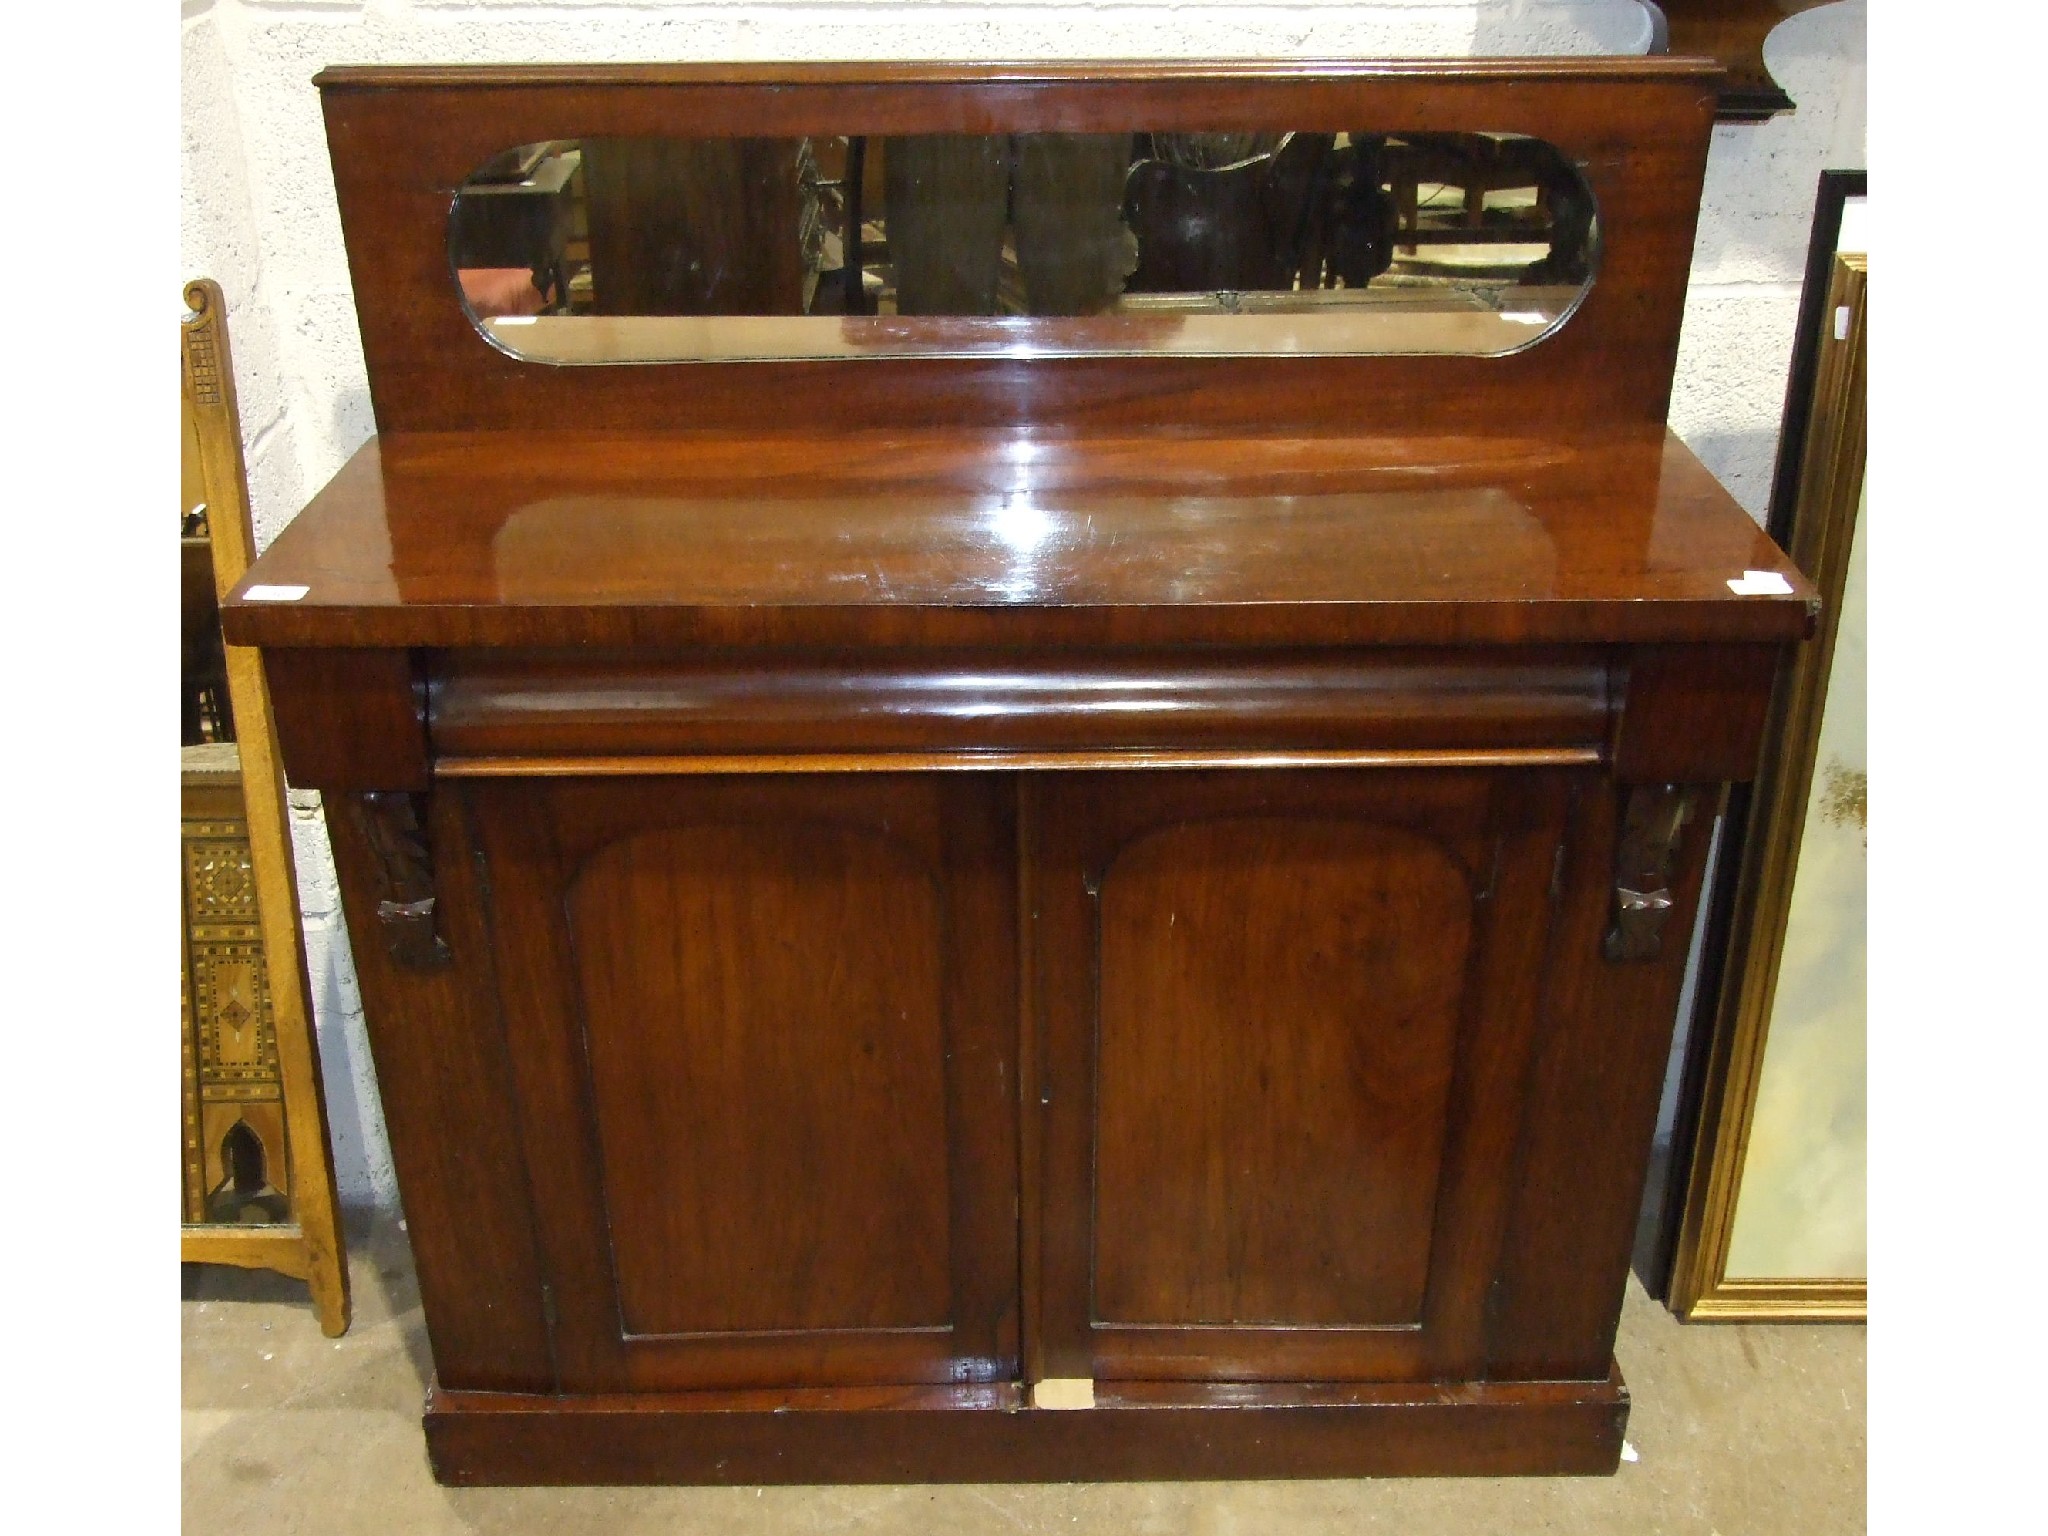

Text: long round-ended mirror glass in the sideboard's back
xmin=449 ymin=133 xmax=1599 ymax=362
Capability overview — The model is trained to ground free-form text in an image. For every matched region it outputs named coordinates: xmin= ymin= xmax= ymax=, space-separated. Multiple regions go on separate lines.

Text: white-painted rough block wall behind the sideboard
xmin=166 ymin=0 xmax=1864 ymax=1206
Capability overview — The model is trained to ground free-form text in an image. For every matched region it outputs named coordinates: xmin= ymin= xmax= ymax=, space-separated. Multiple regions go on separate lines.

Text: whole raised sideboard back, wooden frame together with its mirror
xmin=317 ymin=59 xmax=1712 ymax=436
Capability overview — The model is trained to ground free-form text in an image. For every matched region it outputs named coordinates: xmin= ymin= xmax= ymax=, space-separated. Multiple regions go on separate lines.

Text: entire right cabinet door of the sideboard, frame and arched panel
xmin=1024 ymin=770 xmax=1583 ymax=1382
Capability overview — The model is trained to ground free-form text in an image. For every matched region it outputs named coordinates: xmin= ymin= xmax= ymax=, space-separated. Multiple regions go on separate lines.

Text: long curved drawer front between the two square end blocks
xmin=430 ymin=649 xmax=1612 ymax=772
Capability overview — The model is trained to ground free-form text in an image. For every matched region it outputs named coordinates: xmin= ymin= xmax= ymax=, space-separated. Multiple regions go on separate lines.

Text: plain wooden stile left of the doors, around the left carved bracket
xmin=328 ymin=791 xmax=555 ymax=1393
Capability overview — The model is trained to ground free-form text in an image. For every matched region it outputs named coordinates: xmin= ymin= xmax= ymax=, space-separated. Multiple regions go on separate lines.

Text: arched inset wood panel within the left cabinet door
xmin=565 ymin=825 xmax=948 ymax=1333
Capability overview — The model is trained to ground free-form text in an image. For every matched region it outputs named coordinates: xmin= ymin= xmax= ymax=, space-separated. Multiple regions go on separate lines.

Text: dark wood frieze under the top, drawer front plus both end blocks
xmin=268 ymin=645 xmax=1776 ymax=794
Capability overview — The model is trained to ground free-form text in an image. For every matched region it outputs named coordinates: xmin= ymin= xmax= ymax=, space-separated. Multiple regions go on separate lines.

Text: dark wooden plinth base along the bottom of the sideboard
xmin=426 ymin=1372 xmax=1628 ymax=1485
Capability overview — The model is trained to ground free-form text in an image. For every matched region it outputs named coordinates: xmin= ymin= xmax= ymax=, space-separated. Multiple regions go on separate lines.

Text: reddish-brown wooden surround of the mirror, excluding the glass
xmin=319 ymin=57 xmax=1718 ymax=440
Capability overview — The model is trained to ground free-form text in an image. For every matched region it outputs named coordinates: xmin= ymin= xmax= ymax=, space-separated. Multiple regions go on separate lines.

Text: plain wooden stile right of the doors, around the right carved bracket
xmin=1489 ymin=782 xmax=1714 ymax=1380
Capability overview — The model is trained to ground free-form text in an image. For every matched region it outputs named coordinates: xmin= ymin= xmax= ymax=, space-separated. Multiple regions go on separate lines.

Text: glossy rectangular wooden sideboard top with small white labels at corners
xmin=223 ymin=428 xmax=1817 ymax=647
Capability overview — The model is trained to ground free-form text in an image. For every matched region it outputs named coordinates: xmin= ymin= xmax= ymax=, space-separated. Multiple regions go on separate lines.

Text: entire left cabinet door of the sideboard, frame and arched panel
xmin=467 ymin=774 xmax=1018 ymax=1391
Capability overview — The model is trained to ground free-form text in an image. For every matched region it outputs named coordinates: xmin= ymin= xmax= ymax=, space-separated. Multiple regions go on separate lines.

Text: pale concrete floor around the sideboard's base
xmin=184 ymin=1221 xmax=1864 ymax=1536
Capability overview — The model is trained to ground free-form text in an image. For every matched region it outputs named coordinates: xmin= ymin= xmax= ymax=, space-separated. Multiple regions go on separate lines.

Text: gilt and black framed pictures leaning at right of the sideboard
xmin=1636 ymin=172 xmax=1868 ymax=1321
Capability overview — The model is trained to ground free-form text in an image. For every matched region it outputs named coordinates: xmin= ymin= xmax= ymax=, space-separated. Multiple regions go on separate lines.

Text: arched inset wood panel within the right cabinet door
xmin=1094 ymin=817 xmax=1473 ymax=1327
